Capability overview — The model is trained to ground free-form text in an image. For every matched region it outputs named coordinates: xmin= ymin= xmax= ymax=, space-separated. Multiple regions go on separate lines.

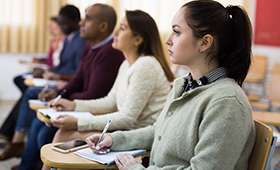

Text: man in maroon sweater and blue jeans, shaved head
xmin=11 ymin=4 xmax=124 ymax=169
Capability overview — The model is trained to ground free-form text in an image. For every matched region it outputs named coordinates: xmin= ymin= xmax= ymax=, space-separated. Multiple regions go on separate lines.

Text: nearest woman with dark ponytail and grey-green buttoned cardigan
xmin=86 ymin=0 xmax=255 ymax=170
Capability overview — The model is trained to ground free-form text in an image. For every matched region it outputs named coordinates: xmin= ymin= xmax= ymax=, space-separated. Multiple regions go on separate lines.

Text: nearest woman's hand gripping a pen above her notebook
xmin=86 ymin=134 xmax=113 ymax=154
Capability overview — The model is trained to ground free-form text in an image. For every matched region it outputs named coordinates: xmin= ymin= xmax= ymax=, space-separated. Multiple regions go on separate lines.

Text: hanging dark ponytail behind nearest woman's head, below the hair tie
xmin=224 ymin=6 xmax=252 ymax=86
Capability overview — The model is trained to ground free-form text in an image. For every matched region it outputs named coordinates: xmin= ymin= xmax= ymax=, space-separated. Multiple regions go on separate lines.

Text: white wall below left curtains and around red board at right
xmin=0 ymin=0 xmax=280 ymax=100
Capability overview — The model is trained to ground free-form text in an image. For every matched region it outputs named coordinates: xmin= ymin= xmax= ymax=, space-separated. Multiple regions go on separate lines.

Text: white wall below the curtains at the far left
xmin=0 ymin=53 xmax=32 ymax=100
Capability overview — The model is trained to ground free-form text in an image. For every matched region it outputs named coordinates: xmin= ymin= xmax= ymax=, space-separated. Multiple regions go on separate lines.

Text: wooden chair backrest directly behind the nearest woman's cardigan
xmin=249 ymin=120 xmax=273 ymax=170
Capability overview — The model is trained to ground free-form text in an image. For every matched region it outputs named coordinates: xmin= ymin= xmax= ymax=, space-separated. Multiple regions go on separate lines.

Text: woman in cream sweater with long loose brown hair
xmin=50 ymin=10 xmax=173 ymax=142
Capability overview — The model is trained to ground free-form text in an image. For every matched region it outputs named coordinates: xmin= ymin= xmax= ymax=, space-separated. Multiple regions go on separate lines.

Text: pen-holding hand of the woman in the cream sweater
xmin=48 ymin=98 xmax=76 ymax=111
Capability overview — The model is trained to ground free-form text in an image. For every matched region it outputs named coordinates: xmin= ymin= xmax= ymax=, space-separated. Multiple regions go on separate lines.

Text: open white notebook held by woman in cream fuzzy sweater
xmin=38 ymin=109 xmax=93 ymax=120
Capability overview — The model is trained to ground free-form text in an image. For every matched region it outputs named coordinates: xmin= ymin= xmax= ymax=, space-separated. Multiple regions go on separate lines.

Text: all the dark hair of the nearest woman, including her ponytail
xmin=182 ymin=0 xmax=252 ymax=86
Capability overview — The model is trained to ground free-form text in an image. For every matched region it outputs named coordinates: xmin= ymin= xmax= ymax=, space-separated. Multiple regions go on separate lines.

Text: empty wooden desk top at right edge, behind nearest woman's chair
xmin=253 ymin=111 xmax=280 ymax=126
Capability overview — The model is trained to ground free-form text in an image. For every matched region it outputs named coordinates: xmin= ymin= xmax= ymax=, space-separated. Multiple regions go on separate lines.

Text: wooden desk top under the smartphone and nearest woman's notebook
xmin=41 ymin=143 xmax=149 ymax=169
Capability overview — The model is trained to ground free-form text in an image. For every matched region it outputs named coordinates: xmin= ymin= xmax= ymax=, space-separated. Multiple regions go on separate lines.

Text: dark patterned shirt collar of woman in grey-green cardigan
xmin=183 ymin=67 xmax=228 ymax=93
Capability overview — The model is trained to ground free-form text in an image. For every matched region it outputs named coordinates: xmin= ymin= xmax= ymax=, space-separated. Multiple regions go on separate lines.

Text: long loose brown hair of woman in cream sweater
xmin=126 ymin=10 xmax=174 ymax=81
